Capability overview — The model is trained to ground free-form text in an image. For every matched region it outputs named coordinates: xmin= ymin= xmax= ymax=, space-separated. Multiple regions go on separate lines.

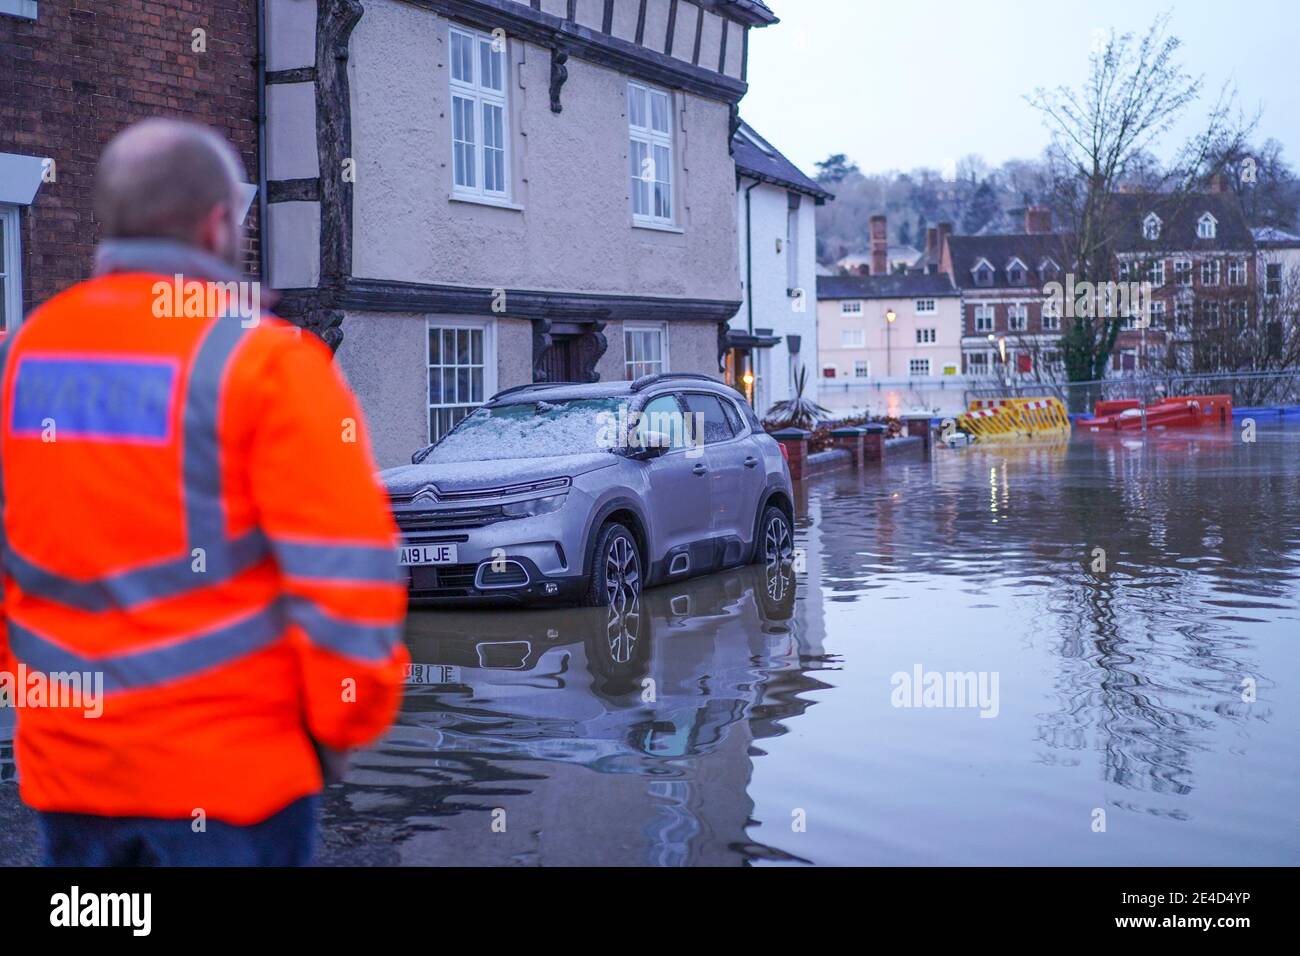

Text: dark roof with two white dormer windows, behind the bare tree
xmin=1110 ymin=193 xmax=1255 ymax=252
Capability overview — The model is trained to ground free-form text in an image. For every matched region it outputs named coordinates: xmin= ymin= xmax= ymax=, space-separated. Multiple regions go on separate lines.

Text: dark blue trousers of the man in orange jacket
xmin=36 ymin=796 xmax=320 ymax=866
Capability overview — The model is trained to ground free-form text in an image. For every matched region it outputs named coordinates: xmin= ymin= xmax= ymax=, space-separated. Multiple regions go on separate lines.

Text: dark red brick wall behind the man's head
xmin=0 ymin=0 xmax=257 ymax=311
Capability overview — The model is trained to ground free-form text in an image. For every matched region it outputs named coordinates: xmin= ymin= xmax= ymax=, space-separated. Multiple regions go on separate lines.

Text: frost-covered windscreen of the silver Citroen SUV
xmin=424 ymin=398 xmax=627 ymax=464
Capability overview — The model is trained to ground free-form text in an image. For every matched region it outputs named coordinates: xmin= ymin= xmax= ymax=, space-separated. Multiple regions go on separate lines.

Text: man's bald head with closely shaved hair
xmin=95 ymin=120 xmax=243 ymax=261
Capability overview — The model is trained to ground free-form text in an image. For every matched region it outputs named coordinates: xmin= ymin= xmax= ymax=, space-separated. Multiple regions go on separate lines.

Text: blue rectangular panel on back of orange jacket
xmin=9 ymin=355 xmax=177 ymax=442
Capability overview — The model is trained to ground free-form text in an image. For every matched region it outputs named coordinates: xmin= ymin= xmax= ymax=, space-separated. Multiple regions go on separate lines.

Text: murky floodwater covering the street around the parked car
xmin=0 ymin=423 xmax=1300 ymax=866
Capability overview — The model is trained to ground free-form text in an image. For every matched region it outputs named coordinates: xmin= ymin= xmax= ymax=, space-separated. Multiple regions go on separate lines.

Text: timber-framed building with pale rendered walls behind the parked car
xmin=258 ymin=0 xmax=775 ymax=464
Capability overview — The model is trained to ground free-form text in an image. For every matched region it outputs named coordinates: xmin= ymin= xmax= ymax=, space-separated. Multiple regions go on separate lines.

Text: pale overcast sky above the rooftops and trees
xmin=741 ymin=0 xmax=1300 ymax=176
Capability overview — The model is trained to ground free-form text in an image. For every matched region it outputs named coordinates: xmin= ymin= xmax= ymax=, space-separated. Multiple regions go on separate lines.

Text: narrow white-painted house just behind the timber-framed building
xmin=725 ymin=121 xmax=835 ymax=415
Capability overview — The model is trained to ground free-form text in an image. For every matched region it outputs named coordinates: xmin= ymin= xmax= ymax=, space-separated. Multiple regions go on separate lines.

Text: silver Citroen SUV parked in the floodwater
xmin=381 ymin=373 xmax=794 ymax=606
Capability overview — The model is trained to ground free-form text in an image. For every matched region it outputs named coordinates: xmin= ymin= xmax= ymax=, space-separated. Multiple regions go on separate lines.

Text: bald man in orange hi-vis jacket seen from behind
xmin=0 ymin=120 xmax=407 ymax=865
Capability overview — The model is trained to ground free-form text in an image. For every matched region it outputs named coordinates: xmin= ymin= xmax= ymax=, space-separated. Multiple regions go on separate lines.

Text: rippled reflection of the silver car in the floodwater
xmin=403 ymin=562 xmax=800 ymax=773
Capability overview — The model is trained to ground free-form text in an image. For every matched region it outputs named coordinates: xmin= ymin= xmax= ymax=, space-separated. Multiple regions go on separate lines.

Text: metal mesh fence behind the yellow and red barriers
xmin=965 ymin=368 xmax=1300 ymax=412
